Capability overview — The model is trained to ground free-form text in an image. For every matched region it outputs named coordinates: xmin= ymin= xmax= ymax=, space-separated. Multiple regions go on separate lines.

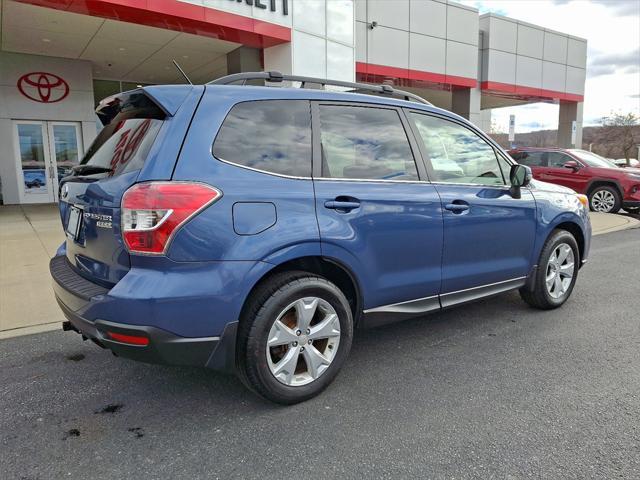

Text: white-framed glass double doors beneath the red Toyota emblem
xmin=15 ymin=121 xmax=82 ymax=203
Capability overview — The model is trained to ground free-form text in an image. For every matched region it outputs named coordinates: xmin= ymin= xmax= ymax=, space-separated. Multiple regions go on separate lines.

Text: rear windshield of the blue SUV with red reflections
xmin=80 ymin=92 xmax=166 ymax=176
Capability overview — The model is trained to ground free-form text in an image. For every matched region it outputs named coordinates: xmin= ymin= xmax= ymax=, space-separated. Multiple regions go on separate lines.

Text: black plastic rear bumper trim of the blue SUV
xmin=49 ymin=257 xmax=237 ymax=372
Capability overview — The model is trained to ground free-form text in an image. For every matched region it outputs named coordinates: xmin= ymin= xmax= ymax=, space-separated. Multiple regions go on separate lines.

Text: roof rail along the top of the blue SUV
xmin=207 ymin=71 xmax=431 ymax=105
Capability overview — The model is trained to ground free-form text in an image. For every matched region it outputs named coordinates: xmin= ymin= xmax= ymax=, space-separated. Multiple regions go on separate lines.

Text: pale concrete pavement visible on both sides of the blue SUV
xmin=0 ymin=205 xmax=640 ymax=339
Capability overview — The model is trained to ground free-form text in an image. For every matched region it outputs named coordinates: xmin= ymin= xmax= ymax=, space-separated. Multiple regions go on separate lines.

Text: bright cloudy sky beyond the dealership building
xmin=458 ymin=0 xmax=640 ymax=132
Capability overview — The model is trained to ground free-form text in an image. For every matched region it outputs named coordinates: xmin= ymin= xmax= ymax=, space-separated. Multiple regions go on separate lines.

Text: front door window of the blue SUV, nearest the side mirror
xmin=411 ymin=112 xmax=508 ymax=185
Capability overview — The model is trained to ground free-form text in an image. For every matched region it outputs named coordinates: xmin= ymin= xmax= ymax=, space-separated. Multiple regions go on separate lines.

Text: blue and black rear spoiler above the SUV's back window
xmin=96 ymin=85 xmax=194 ymax=125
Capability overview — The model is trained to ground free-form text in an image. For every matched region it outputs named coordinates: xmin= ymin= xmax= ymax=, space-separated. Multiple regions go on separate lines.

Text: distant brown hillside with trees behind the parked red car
xmin=491 ymin=125 xmax=640 ymax=158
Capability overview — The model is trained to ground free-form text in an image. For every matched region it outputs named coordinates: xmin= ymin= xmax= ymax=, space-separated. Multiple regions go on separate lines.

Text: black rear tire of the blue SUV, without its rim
xmin=236 ymin=271 xmax=353 ymax=405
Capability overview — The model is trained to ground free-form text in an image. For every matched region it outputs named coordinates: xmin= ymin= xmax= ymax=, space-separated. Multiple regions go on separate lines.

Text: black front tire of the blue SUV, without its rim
xmin=520 ymin=230 xmax=580 ymax=310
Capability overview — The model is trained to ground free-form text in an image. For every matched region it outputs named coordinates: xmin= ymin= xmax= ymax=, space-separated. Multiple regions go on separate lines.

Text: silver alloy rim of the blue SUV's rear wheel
xmin=266 ymin=297 xmax=340 ymax=387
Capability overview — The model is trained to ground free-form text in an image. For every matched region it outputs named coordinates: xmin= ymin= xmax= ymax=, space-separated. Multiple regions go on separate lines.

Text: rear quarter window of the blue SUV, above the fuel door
xmin=213 ymin=100 xmax=311 ymax=177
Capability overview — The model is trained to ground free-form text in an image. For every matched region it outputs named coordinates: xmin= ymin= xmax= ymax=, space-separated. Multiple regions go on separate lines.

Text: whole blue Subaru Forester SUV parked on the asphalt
xmin=50 ymin=72 xmax=591 ymax=404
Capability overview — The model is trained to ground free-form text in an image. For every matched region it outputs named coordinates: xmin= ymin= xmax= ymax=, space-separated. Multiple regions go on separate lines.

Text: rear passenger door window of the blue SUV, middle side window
xmin=319 ymin=105 xmax=418 ymax=180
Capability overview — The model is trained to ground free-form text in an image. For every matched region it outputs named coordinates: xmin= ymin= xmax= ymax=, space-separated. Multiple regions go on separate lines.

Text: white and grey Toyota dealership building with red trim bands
xmin=0 ymin=0 xmax=587 ymax=204
